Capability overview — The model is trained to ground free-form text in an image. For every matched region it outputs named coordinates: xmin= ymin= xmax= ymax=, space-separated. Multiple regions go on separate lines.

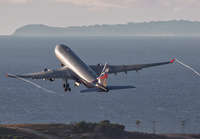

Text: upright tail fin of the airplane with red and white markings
xmin=98 ymin=63 xmax=109 ymax=87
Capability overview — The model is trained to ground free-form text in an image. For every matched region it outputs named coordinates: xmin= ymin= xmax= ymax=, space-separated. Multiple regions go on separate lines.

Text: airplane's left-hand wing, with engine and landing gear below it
xmin=6 ymin=67 xmax=72 ymax=79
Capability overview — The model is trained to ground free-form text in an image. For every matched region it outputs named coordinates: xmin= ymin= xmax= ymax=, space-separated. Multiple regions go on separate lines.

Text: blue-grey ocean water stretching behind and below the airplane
xmin=0 ymin=36 xmax=200 ymax=133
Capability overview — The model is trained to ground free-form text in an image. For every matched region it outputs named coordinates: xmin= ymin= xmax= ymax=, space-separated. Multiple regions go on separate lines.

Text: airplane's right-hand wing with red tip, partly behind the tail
xmin=90 ymin=58 xmax=175 ymax=75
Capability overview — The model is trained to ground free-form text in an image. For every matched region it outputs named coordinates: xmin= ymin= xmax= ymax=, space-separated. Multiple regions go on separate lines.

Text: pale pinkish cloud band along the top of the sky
xmin=54 ymin=0 xmax=200 ymax=11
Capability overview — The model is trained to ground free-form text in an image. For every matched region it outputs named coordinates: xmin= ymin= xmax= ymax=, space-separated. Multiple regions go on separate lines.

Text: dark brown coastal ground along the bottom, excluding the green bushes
xmin=0 ymin=124 xmax=200 ymax=139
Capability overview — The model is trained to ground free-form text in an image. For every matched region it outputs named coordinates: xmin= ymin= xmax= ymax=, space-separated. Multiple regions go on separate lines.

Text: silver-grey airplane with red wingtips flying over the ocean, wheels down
xmin=6 ymin=44 xmax=175 ymax=92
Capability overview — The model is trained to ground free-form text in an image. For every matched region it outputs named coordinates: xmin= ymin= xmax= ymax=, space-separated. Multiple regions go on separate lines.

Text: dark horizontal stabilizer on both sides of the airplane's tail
xmin=81 ymin=86 xmax=135 ymax=93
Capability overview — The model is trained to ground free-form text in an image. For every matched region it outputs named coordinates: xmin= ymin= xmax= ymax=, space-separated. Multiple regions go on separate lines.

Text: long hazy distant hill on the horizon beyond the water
xmin=13 ymin=20 xmax=200 ymax=36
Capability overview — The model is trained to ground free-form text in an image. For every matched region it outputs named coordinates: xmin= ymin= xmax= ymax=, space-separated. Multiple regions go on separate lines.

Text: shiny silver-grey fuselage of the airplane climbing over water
xmin=55 ymin=44 xmax=98 ymax=88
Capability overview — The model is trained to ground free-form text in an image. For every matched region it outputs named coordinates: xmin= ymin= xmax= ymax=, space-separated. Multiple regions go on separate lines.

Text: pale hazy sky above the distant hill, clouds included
xmin=0 ymin=0 xmax=200 ymax=35
